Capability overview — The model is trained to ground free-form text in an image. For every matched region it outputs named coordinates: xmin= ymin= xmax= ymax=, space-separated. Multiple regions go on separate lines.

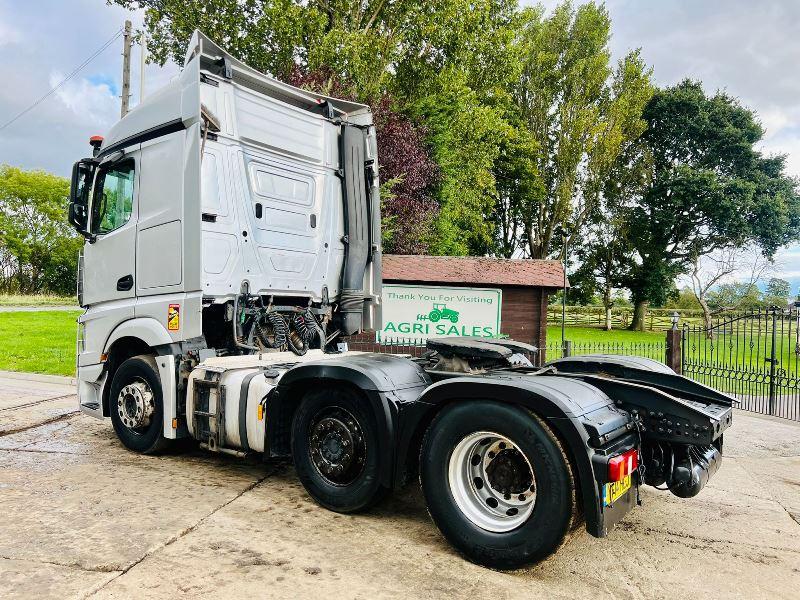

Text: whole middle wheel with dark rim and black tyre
xmin=292 ymin=388 xmax=386 ymax=513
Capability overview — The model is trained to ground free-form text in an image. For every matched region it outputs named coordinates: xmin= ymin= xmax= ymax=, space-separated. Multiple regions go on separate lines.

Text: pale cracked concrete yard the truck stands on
xmin=0 ymin=378 xmax=800 ymax=600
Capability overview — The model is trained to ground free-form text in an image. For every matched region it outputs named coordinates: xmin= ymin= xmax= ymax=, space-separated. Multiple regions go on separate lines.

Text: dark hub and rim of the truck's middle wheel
xmin=309 ymin=407 xmax=366 ymax=485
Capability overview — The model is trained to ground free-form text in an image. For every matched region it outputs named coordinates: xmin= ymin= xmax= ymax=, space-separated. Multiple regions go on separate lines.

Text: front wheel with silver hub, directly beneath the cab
xmin=108 ymin=354 xmax=169 ymax=454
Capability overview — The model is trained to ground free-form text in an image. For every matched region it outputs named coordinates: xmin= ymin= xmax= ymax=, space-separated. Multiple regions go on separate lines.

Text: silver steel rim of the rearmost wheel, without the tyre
xmin=448 ymin=431 xmax=536 ymax=533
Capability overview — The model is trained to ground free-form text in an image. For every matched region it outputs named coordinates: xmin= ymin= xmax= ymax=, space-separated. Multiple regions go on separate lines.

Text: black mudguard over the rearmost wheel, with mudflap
xmin=410 ymin=374 xmax=639 ymax=537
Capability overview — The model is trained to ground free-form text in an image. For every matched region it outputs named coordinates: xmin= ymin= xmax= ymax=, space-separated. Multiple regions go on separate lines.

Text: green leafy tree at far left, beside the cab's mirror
xmin=0 ymin=165 xmax=82 ymax=295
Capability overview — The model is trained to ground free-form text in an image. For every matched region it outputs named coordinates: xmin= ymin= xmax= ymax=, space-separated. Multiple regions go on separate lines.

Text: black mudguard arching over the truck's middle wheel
xmin=267 ymin=353 xmax=431 ymax=487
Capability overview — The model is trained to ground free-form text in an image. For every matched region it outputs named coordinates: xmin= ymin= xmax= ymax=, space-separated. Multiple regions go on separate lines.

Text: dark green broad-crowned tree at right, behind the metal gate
xmin=617 ymin=80 xmax=800 ymax=329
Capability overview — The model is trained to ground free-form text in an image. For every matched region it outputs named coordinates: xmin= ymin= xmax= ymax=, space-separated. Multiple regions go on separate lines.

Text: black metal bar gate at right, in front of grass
xmin=681 ymin=306 xmax=800 ymax=421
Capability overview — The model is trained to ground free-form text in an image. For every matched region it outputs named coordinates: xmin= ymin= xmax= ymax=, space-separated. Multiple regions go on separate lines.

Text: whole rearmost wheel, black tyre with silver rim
xmin=420 ymin=401 xmax=577 ymax=569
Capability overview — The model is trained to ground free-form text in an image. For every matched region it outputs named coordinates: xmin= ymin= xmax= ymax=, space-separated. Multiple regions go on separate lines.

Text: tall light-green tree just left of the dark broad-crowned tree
xmin=498 ymin=2 xmax=653 ymax=258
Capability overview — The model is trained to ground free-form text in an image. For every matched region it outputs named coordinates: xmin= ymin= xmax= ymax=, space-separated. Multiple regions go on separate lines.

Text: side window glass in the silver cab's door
xmin=92 ymin=160 xmax=134 ymax=235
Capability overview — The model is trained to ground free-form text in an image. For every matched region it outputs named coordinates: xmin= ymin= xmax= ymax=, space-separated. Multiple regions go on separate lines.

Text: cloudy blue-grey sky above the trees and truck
xmin=0 ymin=0 xmax=800 ymax=291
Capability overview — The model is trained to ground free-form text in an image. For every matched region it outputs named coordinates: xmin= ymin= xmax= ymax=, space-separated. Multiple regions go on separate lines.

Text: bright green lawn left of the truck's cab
xmin=0 ymin=310 xmax=81 ymax=375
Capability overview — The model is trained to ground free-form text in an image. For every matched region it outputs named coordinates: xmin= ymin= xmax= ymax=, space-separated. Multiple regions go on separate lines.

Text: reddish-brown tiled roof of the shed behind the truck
xmin=383 ymin=254 xmax=569 ymax=288
